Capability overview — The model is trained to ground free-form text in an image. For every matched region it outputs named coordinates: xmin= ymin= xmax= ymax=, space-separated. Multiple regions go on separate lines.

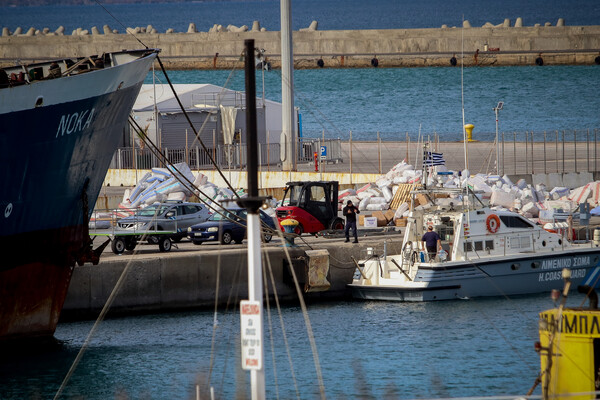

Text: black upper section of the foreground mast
xmin=244 ymin=39 xmax=258 ymax=203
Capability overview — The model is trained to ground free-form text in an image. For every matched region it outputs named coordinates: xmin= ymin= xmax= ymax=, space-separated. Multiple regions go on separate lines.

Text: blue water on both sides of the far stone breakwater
xmin=0 ymin=0 xmax=600 ymax=140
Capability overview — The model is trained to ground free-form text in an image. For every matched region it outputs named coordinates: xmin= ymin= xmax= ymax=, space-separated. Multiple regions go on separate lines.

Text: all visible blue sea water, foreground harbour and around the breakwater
xmin=0 ymin=0 xmax=600 ymax=400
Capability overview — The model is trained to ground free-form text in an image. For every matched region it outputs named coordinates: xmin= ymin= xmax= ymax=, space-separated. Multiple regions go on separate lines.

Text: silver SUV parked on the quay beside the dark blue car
xmin=117 ymin=201 xmax=210 ymax=243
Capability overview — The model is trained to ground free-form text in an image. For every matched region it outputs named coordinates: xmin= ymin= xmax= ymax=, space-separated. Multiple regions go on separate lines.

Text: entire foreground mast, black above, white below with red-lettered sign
xmin=238 ymin=39 xmax=266 ymax=400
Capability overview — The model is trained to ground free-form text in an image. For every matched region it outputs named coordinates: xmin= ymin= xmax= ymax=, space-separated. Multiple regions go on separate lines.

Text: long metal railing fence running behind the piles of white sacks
xmin=110 ymin=129 xmax=600 ymax=175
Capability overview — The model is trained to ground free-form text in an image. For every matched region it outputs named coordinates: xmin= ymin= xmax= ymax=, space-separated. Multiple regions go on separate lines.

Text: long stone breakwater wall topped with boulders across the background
xmin=0 ymin=21 xmax=600 ymax=69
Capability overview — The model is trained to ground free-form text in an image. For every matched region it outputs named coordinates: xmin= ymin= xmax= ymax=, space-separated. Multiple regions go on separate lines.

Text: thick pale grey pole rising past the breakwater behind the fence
xmin=280 ymin=0 xmax=298 ymax=171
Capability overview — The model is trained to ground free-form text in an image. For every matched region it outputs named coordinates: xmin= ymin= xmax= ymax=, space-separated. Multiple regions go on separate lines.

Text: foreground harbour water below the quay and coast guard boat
xmin=0 ymin=292 xmax=582 ymax=400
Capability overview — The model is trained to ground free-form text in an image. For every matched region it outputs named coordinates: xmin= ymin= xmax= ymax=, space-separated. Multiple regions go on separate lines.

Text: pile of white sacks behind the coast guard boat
xmin=339 ymin=161 xmax=600 ymax=220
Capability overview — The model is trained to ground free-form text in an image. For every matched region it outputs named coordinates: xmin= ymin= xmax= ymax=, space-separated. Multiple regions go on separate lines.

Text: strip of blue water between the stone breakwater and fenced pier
xmin=152 ymin=65 xmax=600 ymax=141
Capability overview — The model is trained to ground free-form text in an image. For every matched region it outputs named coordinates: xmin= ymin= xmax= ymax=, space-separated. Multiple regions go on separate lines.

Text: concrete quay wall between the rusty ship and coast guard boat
xmin=63 ymin=239 xmax=400 ymax=318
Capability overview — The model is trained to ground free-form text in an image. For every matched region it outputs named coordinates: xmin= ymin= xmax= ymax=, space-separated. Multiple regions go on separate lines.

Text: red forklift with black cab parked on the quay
xmin=277 ymin=181 xmax=344 ymax=235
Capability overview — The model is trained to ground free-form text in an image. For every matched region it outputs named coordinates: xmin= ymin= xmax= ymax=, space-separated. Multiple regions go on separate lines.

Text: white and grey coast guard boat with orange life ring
xmin=349 ymin=183 xmax=600 ymax=301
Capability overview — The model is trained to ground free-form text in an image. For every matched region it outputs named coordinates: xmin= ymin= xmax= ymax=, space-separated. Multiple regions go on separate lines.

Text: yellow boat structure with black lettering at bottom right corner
xmin=532 ymin=269 xmax=600 ymax=399
